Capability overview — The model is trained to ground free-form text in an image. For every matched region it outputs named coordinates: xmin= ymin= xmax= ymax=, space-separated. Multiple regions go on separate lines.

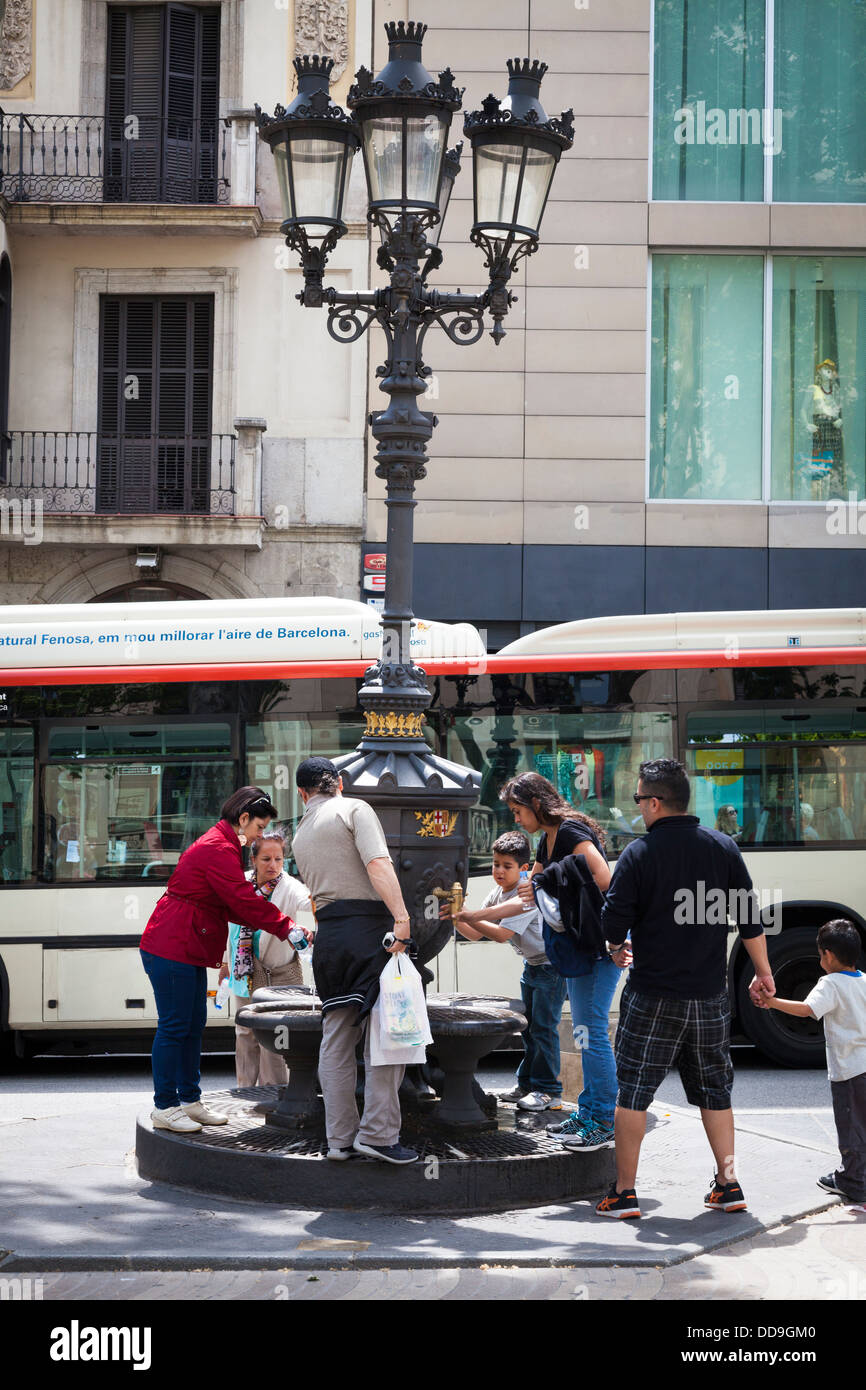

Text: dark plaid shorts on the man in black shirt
xmin=616 ymin=984 xmax=734 ymax=1111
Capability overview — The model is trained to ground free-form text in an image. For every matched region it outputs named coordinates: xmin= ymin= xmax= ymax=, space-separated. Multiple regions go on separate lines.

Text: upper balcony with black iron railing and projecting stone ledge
xmin=0 ymin=111 xmax=261 ymax=235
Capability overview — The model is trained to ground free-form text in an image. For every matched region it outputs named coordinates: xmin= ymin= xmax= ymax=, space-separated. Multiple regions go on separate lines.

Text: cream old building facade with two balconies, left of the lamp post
xmin=0 ymin=0 xmax=371 ymax=603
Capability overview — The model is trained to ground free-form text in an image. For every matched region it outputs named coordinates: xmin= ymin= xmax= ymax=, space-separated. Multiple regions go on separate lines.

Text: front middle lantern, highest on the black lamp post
xmin=348 ymin=19 xmax=463 ymax=227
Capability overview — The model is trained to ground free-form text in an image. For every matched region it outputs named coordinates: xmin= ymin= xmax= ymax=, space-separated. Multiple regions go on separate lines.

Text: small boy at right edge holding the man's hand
xmin=759 ymin=917 xmax=866 ymax=1202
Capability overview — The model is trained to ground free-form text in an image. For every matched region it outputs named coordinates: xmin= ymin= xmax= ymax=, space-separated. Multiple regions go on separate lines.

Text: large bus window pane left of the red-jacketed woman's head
xmin=43 ymin=760 xmax=235 ymax=881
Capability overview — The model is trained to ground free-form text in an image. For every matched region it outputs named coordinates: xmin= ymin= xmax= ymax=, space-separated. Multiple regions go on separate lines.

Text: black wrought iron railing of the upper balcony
xmin=0 ymin=111 xmax=231 ymax=204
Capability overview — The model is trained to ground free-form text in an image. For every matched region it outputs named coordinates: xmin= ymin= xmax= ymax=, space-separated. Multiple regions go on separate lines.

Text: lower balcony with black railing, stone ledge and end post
xmin=0 ymin=428 xmax=263 ymax=549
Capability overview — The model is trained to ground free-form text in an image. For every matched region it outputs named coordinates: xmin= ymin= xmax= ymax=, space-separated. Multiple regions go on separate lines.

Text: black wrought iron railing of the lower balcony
xmin=0 ymin=430 xmax=236 ymax=516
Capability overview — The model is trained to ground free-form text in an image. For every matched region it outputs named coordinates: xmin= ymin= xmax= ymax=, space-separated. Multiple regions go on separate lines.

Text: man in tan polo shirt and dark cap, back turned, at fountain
xmin=292 ymin=758 xmax=418 ymax=1163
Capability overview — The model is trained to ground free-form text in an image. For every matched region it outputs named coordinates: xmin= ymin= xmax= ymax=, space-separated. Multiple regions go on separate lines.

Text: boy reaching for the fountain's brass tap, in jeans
xmin=443 ymin=830 xmax=566 ymax=1111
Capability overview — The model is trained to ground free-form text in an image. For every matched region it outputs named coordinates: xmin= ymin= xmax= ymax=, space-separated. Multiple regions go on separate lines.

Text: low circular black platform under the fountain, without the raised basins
xmin=135 ymin=1086 xmax=614 ymax=1216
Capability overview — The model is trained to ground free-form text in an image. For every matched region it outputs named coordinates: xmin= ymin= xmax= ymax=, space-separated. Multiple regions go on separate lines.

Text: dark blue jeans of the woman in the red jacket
xmin=142 ymin=951 xmax=207 ymax=1111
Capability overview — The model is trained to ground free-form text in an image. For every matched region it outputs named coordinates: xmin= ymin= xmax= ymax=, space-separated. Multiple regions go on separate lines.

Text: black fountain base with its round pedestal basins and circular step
xmin=135 ymin=990 xmax=614 ymax=1216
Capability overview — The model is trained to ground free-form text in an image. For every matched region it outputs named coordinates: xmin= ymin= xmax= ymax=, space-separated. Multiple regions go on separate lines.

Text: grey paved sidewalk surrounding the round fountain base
xmin=0 ymin=1073 xmax=862 ymax=1282
